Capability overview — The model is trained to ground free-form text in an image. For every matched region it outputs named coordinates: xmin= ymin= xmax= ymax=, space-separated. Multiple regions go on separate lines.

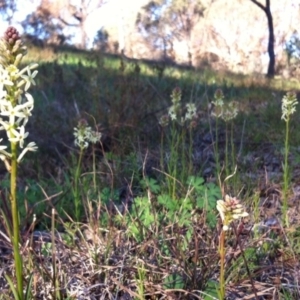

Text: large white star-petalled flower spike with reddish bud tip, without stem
xmin=0 ymin=27 xmax=38 ymax=170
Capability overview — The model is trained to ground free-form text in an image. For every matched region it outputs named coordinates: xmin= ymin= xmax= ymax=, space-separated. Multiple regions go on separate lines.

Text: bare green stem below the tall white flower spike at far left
xmin=10 ymin=143 xmax=23 ymax=300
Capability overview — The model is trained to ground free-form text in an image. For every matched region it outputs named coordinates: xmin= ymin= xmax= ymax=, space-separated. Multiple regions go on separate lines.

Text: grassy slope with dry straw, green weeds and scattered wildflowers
xmin=0 ymin=29 xmax=300 ymax=299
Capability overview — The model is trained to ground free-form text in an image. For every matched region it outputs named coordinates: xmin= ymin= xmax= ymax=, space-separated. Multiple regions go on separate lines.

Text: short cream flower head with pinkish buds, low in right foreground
xmin=217 ymin=195 xmax=249 ymax=231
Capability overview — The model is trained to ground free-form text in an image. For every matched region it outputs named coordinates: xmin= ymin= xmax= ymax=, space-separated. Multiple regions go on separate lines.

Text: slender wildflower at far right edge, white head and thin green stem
xmin=281 ymin=92 xmax=298 ymax=227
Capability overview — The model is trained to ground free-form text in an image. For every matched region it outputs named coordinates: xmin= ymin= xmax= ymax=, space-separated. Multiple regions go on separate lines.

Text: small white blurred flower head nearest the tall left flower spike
xmin=74 ymin=119 xmax=102 ymax=150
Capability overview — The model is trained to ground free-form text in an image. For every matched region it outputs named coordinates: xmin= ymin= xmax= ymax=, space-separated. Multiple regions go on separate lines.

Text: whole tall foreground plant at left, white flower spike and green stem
xmin=0 ymin=27 xmax=38 ymax=300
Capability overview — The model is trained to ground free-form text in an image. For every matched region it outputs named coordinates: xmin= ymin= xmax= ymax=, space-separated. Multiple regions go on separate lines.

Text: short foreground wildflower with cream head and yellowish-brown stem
xmin=217 ymin=195 xmax=248 ymax=300
